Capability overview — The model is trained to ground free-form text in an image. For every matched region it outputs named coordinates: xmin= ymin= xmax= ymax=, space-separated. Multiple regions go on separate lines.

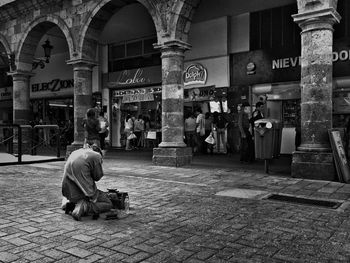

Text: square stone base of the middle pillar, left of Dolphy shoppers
xmin=152 ymin=147 xmax=192 ymax=167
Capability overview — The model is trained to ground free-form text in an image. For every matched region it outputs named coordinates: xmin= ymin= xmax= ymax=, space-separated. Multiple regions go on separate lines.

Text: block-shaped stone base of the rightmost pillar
xmin=291 ymin=151 xmax=337 ymax=181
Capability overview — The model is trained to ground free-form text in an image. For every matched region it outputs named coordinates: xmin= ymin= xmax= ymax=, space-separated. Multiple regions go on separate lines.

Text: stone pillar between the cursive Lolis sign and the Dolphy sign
xmin=153 ymin=40 xmax=192 ymax=166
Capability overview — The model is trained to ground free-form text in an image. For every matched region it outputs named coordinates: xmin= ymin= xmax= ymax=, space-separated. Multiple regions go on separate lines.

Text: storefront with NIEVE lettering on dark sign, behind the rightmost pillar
xmin=231 ymin=40 xmax=350 ymax=154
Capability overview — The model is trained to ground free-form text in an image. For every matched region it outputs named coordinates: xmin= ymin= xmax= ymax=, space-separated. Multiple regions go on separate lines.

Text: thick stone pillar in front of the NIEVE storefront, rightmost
xmin=292 ymin=0 xmax=340 ymax=180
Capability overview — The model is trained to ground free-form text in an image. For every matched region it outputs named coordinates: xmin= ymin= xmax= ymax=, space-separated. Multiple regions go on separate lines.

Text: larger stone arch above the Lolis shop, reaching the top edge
xmin=78 ymin=0 xmax=160 ymax=61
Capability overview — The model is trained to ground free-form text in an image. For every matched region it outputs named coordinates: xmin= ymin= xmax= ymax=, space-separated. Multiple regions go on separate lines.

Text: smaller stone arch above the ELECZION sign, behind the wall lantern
xmin=16 ymin=15 xmax=76 ymax=68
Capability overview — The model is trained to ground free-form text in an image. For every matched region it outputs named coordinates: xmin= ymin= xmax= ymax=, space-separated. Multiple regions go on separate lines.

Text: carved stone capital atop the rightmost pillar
xmin=292 ymin=7 xmax=341 ymax=32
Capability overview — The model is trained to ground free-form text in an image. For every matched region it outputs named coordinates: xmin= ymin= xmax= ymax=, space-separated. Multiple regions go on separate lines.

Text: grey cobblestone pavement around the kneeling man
xmin=0 ymin=159 xmax=350 ymax=263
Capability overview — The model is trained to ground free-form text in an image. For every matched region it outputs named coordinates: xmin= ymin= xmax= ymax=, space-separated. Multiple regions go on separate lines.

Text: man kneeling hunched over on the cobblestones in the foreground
xmin=62 ymin=144 xmax=112 ymax=221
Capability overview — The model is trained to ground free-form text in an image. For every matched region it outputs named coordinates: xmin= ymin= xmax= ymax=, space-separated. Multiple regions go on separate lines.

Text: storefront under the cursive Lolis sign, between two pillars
xmin=103 ymin=66 xmax=162 ymax=147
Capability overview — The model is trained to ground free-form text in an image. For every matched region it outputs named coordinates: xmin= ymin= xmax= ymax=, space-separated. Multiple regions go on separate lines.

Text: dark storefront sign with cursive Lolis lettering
xmin=107 ymin=66 xmax=161 ymax=88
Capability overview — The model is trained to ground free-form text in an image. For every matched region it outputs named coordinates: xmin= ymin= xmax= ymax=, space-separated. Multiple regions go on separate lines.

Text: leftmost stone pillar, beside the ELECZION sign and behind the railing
xmin=8 ymin=70 xmax=34 ymax=153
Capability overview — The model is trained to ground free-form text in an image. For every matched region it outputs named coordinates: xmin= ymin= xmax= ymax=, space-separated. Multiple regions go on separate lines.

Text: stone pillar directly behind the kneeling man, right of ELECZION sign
xmin=66 ymin=59 xmax=96 ymax=157
